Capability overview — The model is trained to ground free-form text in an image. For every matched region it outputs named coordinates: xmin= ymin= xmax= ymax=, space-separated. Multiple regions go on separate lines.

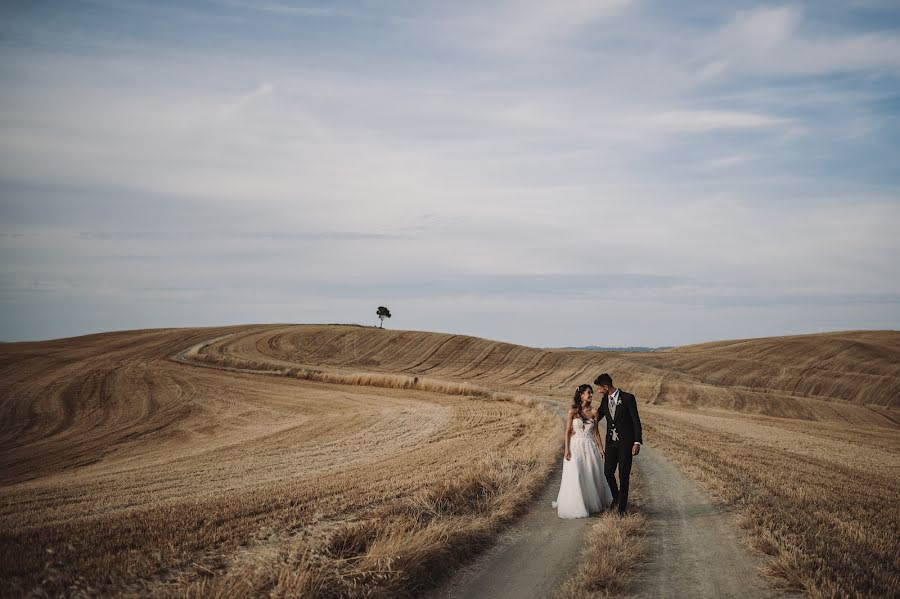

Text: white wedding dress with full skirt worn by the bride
xmin=553 ymin=418 xmax=612 ymax=518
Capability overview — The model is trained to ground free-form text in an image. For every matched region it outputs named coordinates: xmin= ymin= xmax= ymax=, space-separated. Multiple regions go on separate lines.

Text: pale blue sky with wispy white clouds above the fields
xmin=0 ymin=0 xmax=900 ymax=347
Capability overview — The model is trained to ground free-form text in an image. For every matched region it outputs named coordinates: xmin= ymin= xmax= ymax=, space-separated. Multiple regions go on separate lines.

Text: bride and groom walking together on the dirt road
xmin=553 ymin=373 xmax=643 ymax=518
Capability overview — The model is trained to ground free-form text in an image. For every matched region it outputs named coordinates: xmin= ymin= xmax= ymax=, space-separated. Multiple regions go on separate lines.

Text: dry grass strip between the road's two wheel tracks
xmin=559 ymin=472 xmax=650 ymax=599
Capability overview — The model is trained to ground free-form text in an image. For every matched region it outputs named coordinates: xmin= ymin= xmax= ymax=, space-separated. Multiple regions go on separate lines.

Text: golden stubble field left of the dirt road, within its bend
xmin=0 ymin=327 xmax=558 ymax=597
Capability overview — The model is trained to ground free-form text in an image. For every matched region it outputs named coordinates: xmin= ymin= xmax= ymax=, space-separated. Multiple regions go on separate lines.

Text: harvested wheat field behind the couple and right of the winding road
xmin=179 ymin=326 xmax=900 ymax=597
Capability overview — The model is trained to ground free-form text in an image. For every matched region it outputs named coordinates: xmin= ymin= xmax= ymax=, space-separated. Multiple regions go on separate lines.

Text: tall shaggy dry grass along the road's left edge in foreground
xmin=175 ymin=461 xmax=538 ymax=597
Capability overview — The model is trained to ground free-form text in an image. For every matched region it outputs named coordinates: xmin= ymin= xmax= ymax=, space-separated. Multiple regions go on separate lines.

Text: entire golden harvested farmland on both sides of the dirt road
xmin=0 ymin=325 xmax=900 ymax=597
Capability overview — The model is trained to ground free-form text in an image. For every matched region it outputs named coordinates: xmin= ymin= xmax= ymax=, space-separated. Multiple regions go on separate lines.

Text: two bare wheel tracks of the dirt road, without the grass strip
xmin=431 ymin=436 xmax=781 ymax=599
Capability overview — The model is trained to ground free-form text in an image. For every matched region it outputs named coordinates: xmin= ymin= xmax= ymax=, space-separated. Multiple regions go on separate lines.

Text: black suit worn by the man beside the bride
xmin=598 ymin=389 xmax=644 ymax=513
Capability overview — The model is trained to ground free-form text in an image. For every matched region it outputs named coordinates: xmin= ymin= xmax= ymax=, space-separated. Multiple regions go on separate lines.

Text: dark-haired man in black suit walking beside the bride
xmin=594 ymin=372 xmax=643 ymax=516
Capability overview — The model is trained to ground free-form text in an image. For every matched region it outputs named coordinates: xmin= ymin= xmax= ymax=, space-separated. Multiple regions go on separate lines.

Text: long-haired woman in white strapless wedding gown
xmin=553 ymin=385 xmax=612 ymax=518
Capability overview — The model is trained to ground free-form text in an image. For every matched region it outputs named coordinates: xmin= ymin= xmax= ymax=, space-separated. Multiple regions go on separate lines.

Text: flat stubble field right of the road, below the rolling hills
xmin=641 ymin=407 xmax=900 ymax=598
